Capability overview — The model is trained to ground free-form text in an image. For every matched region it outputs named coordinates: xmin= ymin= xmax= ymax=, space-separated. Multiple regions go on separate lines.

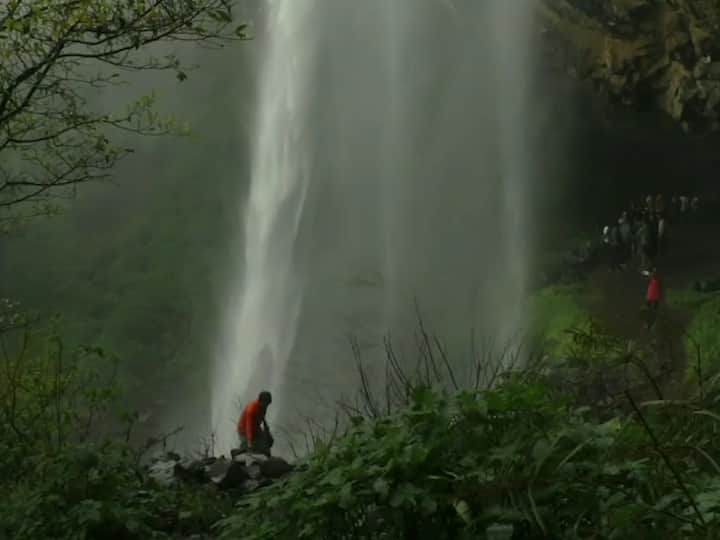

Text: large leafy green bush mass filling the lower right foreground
xmin=219 ymin=362 xmax=720 ymax=540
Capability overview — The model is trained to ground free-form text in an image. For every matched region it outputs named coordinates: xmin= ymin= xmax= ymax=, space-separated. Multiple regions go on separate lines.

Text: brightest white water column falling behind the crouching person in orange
xmin=212 ymin=0 xmax=314 ymax=452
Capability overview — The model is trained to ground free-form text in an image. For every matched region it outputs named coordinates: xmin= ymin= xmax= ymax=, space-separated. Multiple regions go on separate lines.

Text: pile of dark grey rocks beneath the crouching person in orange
xmin=149 ymin=451 xmax=294 ymax=493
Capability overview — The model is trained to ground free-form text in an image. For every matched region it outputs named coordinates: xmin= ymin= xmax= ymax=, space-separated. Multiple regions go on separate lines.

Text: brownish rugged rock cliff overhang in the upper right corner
xmin=539 ymin=0 xmax=720 ymax=133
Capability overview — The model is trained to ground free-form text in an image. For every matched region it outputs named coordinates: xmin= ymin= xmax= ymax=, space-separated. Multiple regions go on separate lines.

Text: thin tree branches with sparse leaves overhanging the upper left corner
xmin=0 ymin=0 xmax=246 ymax=220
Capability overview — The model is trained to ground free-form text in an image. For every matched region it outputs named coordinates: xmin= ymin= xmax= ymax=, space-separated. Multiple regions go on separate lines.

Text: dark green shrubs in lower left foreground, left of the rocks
xmin=0 ymin=302 xmax=227 ymax=540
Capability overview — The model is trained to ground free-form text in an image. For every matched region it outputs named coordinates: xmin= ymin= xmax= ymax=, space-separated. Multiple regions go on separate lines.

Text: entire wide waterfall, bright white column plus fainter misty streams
xmin=212 ymin=0 xmax=534 ymax=451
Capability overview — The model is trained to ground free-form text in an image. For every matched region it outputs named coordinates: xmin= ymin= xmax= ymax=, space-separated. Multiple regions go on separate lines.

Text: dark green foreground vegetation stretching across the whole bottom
xmin=5 ymin=292 xmax=720 ymax=540
